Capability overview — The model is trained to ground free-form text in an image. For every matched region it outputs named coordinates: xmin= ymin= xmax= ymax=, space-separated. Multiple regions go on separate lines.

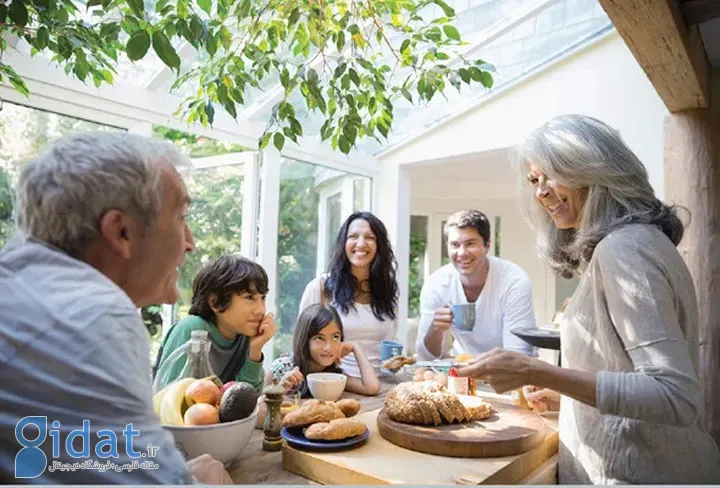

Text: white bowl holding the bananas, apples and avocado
xmin=163 ymin=407 xmax=258 ymax=464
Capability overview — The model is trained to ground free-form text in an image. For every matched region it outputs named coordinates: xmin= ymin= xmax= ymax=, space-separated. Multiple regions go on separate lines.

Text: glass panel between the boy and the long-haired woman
xmin=274 ymin=159 xmax=371 ymax=357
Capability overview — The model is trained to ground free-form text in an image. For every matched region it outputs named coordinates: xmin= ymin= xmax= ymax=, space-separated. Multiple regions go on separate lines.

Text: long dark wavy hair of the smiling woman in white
xmin=324 ymin=212 xmax=398 ymax=320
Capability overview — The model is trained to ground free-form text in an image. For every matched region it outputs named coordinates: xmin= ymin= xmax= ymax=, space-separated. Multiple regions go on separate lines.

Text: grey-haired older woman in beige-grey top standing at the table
xmin=460 ymin=115 xmax=720 ymax=484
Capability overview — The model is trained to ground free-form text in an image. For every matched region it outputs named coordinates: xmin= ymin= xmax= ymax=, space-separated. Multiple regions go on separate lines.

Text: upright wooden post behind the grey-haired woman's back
xmin=665 ymin=109 xmax=720 ymax=445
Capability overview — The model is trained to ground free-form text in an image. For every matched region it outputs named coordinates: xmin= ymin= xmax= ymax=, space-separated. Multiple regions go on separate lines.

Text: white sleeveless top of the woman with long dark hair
xmin=300 ymin=278 xmax=397 ymax=378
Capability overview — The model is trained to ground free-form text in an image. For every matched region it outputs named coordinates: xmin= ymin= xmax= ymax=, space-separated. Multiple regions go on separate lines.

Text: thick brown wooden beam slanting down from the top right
xmin=599 ymin=0 xmax=710 ymax=112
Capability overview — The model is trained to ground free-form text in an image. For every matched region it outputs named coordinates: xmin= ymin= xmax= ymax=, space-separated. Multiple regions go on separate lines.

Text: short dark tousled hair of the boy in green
xmin=188 ymin=254 xmax=268 ymax=323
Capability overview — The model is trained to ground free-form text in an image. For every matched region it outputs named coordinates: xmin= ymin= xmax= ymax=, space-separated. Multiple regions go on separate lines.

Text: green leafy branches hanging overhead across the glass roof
xmin=0 ymin=0 xmax=493 ymax=154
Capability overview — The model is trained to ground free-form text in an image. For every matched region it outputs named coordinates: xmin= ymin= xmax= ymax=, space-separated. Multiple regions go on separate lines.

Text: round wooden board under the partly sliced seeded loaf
xmin=377 ymin=399 xmax=546 ymax=457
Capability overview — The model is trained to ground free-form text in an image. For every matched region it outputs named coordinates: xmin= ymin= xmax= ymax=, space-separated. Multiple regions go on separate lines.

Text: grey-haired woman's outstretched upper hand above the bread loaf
xmin=458 ymin=348 xmax=537 ymax=393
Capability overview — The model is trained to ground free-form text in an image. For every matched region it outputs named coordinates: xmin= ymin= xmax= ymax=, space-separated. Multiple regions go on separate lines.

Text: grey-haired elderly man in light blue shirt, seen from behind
xmin=0 ymin=133 xmax=227 ymax=484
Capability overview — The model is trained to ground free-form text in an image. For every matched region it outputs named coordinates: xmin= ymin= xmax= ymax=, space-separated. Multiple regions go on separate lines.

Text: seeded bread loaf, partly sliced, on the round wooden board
xmin=385 ymin=381 xmax=492 ymax=425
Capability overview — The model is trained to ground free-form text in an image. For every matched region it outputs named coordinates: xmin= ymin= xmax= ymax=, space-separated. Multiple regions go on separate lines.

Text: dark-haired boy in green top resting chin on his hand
xmin=156 ymin=254 xmax=276 ymax=391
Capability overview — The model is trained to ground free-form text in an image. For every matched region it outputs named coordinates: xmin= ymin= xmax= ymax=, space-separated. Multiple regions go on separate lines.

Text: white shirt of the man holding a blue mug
xmin=416 ymin=256 xmax=536 ymax=360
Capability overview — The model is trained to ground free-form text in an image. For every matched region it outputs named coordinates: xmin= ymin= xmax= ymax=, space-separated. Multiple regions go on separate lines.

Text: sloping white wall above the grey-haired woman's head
xmin=380 ymin=31 xmax=668 ymax=197
